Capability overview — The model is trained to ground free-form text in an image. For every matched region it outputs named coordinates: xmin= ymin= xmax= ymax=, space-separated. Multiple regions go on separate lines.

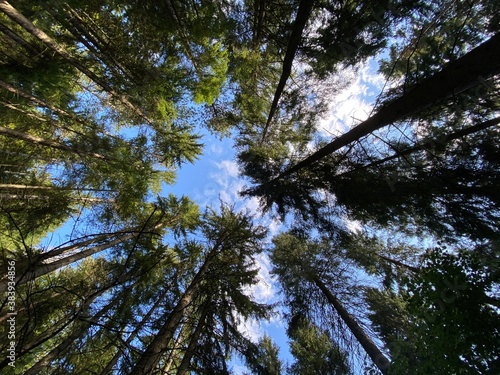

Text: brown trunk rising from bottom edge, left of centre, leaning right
xmin=132 ymin=247 xmax=217 ymax=375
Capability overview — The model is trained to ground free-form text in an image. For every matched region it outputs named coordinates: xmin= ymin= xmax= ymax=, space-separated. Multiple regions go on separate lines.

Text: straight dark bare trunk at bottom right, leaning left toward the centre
xmin=312 ymin=276 xmax=391 ymax=375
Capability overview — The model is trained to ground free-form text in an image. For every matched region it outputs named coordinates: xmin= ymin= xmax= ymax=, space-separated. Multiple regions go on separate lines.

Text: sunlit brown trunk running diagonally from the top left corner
xmin=0 ymin=0 xmax=154 ymax=125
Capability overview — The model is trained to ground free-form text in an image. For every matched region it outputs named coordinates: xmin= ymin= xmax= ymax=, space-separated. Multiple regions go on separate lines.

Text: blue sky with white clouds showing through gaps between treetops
xmin=162 ymin=59 xmax=384 ymax=374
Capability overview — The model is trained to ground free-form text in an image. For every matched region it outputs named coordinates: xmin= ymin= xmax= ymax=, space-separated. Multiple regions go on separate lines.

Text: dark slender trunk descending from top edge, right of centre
xmin=260 ymin=0 xmax=314 ymax=144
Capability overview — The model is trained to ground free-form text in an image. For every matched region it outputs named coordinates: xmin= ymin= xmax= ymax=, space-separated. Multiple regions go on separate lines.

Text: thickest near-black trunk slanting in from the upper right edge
xmin=254 ymin=34 xmax=500 ymax=194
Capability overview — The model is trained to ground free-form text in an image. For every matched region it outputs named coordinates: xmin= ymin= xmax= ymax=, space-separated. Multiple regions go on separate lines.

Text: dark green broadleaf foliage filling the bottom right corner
xmin=394 ymin=243 xmax=500 ymax=374
